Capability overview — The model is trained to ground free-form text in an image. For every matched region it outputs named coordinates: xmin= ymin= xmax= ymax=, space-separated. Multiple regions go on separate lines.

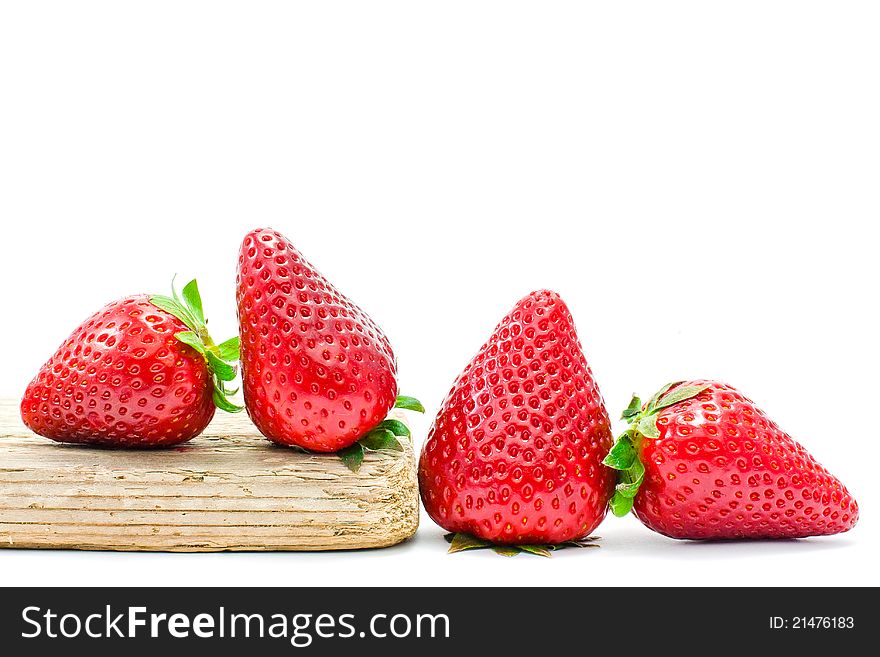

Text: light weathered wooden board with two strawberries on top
xmin=0 ymin=400 xmax=419 ymax=552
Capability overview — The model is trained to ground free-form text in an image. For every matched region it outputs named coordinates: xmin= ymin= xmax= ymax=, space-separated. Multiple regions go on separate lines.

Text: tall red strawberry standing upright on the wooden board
xmin=237 ymin=228 xmax=424 ymax=470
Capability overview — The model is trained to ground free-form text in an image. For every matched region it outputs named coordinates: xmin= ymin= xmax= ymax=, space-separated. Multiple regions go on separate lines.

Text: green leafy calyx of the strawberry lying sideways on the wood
xmin=150 ymin=279 xmax=244 ymax=413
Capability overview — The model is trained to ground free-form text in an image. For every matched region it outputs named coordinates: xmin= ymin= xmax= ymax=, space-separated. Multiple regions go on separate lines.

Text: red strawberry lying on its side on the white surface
xmin=605 ymin=380 xmax=859 ymax=539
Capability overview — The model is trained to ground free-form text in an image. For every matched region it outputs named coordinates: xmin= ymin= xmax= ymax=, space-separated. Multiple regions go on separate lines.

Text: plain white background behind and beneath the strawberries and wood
xmin=0 ymin=0 xmax=880 ymax=585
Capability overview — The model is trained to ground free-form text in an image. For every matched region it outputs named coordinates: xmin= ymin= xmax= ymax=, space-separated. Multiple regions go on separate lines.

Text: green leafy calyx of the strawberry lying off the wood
xmin=602 ymin=381 xmax=709 ymax=517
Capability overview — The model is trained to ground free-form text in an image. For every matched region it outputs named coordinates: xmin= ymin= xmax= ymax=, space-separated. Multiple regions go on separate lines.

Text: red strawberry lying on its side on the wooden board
xmin=21 ymin=280 xmax=241 ymax=447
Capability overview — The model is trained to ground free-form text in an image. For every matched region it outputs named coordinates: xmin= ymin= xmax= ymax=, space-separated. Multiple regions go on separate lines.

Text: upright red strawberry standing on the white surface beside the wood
xmin=419 ymin=290 xmax=614 ymax=551
